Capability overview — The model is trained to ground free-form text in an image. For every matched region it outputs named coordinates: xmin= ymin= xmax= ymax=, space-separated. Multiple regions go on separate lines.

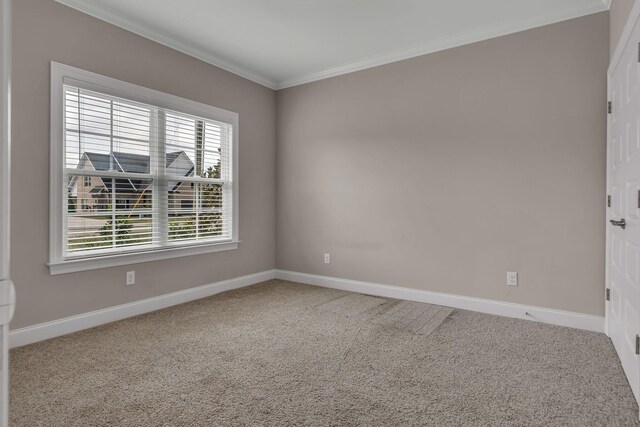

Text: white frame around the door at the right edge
xmin=604 ymin=1 xmax=640 ymax=414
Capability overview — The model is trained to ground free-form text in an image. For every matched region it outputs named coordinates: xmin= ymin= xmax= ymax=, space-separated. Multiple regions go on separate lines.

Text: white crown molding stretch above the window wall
xmin=55 ymin=0 xmax=276 ymax=89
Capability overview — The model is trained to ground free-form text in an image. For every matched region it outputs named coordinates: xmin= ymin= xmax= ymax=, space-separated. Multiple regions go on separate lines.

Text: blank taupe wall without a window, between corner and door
xmin=276 ymin=12 xmax=609 ymax=315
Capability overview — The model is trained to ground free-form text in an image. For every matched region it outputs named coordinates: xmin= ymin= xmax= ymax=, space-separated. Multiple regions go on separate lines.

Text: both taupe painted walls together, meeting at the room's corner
xmin=11 ymin=0 xmax=608 ymax=328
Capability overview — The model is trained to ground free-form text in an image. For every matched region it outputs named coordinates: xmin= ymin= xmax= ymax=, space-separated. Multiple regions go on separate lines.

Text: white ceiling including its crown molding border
xmin=57 ymin=0 xmax=610 ymax=89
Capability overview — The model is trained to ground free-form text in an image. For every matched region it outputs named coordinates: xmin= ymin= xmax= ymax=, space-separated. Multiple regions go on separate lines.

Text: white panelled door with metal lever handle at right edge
xmin=607 ymin=13 xmax=640 ymax=408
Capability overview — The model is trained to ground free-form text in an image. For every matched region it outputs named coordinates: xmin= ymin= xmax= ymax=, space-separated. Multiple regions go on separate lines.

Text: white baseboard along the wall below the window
xmin=9 ymin=270 xmax=275 ymax=348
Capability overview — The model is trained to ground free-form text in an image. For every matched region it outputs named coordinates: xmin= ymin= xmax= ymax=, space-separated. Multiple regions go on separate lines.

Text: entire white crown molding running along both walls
xmin=55 ymin=0 xmax=611 ymax=90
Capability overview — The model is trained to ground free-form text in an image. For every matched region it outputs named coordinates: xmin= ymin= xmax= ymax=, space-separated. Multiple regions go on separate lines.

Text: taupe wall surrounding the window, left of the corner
xmin=11 ymin=0 xmax=275 ymax=328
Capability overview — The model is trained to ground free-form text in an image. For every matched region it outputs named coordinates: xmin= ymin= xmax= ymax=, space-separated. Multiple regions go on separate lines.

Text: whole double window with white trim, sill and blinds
xmin=49 ymin=63 xmax=238 ymax=274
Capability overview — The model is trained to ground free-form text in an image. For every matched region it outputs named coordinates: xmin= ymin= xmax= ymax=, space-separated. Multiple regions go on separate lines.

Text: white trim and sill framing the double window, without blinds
xmin=47 ymin=61 xmax=240 ymax=275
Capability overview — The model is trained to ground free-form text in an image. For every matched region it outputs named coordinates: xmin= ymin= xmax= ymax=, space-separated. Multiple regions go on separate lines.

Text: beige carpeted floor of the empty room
xmin=11 ymin=280 xmax=640 ymax=426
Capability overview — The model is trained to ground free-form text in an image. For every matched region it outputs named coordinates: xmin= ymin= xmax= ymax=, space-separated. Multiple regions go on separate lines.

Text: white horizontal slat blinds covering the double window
xmin=60 ymin=79 xmax=234 ymax=259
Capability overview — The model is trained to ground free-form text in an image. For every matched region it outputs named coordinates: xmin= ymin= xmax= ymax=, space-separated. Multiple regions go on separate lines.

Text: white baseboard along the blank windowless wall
xmin=276 ymin=270 xmax=605 ymax=332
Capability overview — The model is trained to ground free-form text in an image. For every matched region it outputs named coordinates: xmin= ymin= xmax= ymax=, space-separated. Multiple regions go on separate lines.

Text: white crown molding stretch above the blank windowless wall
xmin=276 ymin=0 xmax=610 ymax=89
